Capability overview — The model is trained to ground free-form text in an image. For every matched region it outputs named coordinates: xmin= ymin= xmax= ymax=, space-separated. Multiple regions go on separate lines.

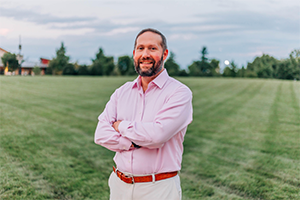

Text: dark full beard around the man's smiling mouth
xmin=134 ymin=55 xmax=163 ymax=77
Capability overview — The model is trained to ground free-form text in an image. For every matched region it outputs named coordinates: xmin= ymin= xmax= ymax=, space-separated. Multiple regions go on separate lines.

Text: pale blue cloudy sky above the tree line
xmin=0 ymin=0 xmax=300 ymax=69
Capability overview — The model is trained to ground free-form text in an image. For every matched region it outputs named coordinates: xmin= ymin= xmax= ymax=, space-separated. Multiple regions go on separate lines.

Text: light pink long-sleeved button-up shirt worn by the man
xmin=95 ymin=70 xmax=193 ymax=175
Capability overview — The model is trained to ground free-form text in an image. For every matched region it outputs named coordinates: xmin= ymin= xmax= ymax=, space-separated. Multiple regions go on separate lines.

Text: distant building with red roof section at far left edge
xmin=0 ymin=48 xmax=50 ymax=76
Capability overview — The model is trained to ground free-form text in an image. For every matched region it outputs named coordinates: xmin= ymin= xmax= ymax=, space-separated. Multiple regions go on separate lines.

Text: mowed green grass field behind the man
xmin=0 ymin=76 xmax=300 ymax=200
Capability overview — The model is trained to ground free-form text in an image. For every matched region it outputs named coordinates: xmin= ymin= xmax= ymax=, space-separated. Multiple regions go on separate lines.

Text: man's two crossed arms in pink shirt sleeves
xmin=95 ymin=87 xmax=192 ymax=152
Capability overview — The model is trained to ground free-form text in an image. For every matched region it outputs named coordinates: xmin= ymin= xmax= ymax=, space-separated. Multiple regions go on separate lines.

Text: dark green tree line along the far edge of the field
xmin=2 ymin=42 xmax=300 ymax=80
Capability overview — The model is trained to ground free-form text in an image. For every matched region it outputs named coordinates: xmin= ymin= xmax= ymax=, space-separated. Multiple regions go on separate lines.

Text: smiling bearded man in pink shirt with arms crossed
xmin=95 ymin=29 xmax=192 ymax=200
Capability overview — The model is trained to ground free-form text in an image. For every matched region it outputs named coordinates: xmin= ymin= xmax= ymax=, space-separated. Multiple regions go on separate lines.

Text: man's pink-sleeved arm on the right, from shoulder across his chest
xmin=118 ymin=86 xmax=193 ymax=148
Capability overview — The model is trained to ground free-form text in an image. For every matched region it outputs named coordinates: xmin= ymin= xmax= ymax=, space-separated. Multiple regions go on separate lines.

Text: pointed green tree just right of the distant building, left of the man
xmin=48 ymin=42 xmax=70 ymax=75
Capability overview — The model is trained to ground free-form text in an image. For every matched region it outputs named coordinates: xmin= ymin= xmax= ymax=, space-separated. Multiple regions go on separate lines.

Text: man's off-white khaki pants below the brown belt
xmin=108 ymin=172 xmax=181 ymax=200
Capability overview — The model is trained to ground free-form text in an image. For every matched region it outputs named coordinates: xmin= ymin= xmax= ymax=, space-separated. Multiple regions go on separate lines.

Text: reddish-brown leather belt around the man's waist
xmin=113 ymin=167 xmax=178 ymax=184
